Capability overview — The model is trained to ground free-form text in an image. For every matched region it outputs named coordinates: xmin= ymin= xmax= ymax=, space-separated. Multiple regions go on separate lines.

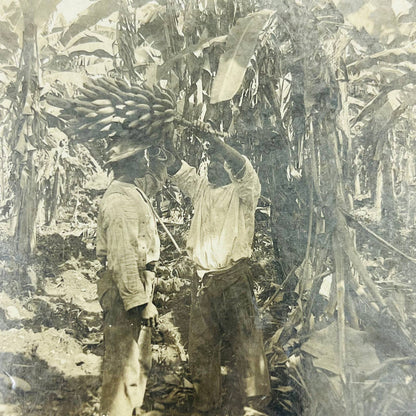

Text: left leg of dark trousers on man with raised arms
xmin=188 ymin=286 xmax=221 ymax=412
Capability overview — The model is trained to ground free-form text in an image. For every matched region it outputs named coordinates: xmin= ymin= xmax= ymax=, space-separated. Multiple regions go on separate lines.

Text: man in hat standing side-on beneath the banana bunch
xmin=97 ymin=139 xmax=166 ymax=416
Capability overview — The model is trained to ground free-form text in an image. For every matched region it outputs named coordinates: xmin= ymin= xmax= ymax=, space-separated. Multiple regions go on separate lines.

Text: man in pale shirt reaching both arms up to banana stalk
xmin=168 ymin=130 xmax=270 ymax=416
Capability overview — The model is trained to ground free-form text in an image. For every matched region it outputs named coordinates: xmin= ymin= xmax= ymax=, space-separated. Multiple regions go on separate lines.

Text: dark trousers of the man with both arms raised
xmin=189 ymin=261 xmax=270 ymax=411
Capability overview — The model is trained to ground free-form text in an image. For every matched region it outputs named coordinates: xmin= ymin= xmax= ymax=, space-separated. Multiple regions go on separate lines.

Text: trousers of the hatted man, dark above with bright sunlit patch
xmin=100 ymin=290 xmax=151 ymax=416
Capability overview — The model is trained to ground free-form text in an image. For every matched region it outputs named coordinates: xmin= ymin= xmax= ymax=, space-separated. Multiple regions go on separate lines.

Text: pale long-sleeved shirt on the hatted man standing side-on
xmin=97 ymin=180 xmax=160 ymax=310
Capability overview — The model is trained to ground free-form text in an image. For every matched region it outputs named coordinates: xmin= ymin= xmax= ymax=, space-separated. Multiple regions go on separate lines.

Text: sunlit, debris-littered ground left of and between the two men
xmin=0 ymin=180 xmax=282 ymax=416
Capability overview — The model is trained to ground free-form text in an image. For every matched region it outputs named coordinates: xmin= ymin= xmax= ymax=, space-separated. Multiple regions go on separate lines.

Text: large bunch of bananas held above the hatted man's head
xmin=47 ymin=77 xmax=177 ymax=147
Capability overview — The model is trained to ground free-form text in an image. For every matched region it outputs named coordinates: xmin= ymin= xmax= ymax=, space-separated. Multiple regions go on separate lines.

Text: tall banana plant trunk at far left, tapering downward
xmin=9 ymin=0 xmax=59 ymax=266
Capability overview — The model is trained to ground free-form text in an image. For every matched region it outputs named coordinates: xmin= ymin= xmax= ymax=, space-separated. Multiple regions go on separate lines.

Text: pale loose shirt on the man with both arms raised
xmin=172 ymin=158 xmax=261 ymax=271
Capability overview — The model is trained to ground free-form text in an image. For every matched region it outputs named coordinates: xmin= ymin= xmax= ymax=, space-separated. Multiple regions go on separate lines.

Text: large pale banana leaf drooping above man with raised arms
xmin=211 ymin=10 xmax=273 ymax=103
